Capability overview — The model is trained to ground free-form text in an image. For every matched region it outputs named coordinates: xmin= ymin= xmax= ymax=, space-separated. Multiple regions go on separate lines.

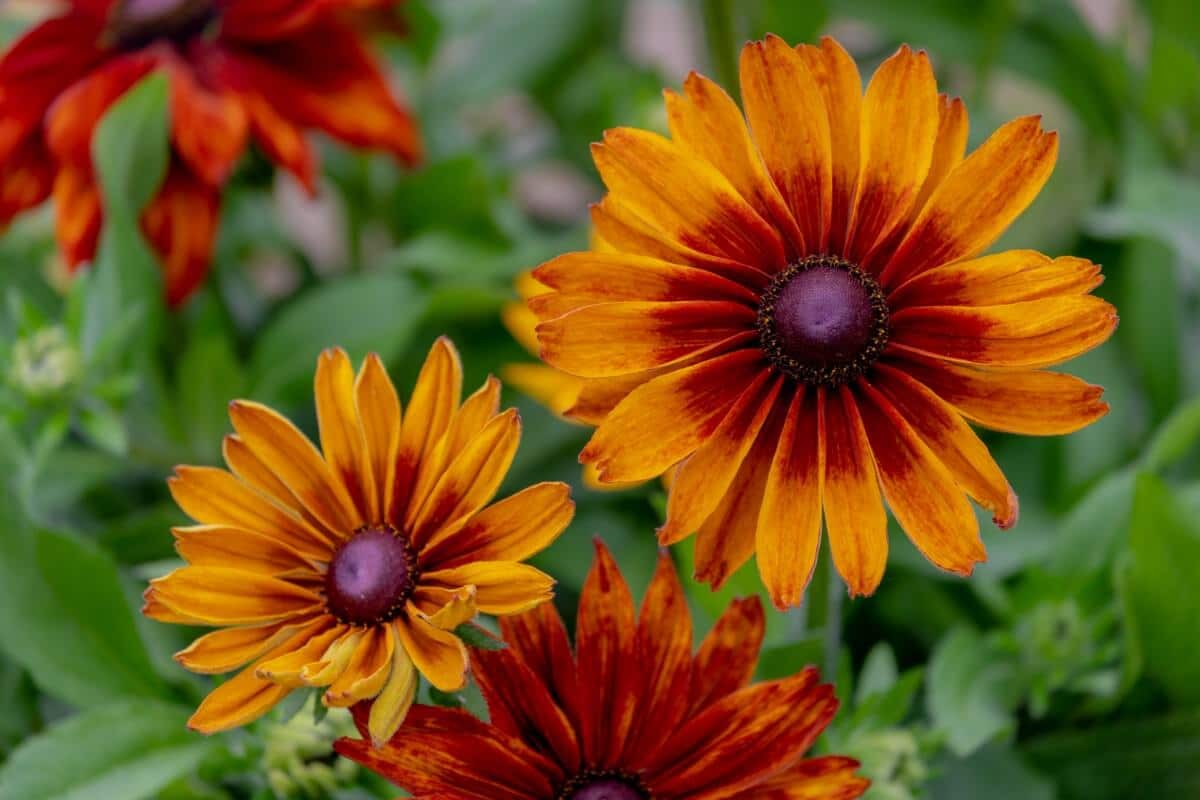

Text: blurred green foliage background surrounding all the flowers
xmin=0 ymin=0 xmax=1200 ymax=800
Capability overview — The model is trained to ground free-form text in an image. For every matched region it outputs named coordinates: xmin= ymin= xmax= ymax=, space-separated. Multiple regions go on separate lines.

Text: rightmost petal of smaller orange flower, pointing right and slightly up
xmin=421 ymin=482 xmax=575 ymax=570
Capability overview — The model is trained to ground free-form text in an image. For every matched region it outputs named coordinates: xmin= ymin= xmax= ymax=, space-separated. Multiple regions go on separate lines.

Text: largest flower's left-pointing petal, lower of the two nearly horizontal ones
xmin=538 ymin=300 xmax=757 ymax=378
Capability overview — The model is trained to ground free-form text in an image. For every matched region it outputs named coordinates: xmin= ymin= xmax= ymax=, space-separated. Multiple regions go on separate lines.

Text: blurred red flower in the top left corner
xmin=0 ymin=0 xmax=421 ymax=303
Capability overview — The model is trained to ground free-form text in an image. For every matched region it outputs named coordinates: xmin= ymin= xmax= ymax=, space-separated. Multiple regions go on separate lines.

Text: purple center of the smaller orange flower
xmin=325 ymin=525 xmax=418 ymax=625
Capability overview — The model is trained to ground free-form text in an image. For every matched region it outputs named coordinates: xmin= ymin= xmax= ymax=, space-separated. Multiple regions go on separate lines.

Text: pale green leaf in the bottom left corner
xmin=0 ymin=700 xmax=214 ymax=800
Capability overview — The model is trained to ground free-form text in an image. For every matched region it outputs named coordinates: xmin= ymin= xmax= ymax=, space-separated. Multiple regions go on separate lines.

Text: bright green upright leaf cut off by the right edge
xmin=1127 ymin=474 xmax=1200 ymax=705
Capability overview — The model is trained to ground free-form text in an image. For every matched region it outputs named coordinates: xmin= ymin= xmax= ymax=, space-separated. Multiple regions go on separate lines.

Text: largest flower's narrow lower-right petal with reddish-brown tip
xmin=875 ymin=363 xmax=1018 ymax=528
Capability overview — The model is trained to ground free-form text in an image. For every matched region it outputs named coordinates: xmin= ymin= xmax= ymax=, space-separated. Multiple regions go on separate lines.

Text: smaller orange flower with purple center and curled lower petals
xmin=144 ymin=338 xmax=574 ymax=741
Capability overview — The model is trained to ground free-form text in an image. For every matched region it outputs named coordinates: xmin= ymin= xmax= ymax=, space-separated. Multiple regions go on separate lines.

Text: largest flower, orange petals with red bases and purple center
xmin=529 ymin=36 xmax=1117 ymax=608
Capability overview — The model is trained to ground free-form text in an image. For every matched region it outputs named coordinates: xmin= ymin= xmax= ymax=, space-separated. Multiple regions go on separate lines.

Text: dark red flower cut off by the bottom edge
xmin=334 ymin=542 xmax=868 ymax=800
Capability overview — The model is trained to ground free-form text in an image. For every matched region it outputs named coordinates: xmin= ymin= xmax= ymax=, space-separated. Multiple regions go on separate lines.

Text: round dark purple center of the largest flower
xmin=758 ymin=255 xmax=888 ymax=386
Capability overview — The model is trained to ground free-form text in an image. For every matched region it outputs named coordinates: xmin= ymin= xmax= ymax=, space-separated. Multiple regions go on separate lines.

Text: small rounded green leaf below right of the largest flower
xmin=925 ymin=627 xmax=1016 ymax=757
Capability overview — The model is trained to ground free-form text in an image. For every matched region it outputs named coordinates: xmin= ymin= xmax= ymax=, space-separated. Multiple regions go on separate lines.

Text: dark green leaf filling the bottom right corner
xmin=1025 ymin=711 xmax=1200 ymax=800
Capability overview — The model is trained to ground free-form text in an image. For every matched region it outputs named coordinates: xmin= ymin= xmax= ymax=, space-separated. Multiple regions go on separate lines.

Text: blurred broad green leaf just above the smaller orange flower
xmin=250 ymin=275 xmax=425 ymax=402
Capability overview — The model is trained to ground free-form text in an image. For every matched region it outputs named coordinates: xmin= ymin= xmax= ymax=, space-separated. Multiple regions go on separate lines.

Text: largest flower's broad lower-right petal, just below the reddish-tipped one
xmin=856 ymin=381 xmax=988 ymax=576
